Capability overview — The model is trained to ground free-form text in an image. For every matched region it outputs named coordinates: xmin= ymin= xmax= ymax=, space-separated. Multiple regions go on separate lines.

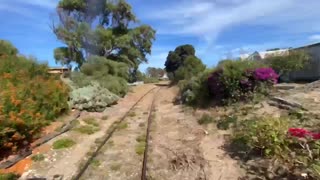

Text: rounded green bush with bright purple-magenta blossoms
xmin=208 ymin=61 xmax=278 ymax=102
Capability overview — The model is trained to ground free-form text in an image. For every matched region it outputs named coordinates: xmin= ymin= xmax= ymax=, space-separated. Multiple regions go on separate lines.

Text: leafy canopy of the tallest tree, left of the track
xmin=53 ymin=0 xmax=155 ymax=69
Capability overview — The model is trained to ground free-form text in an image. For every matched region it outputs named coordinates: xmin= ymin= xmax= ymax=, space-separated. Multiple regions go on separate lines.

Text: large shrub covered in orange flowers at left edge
xmin=0 ymin=56 xmax=69 ymax=151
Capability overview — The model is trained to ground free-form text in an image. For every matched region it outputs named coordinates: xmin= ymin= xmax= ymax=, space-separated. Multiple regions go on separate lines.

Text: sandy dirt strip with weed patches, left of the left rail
xmin=20 ymin=85 xmax=155 ymax=180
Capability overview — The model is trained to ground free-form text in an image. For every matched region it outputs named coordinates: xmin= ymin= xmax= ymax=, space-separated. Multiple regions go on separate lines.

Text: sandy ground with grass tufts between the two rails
xmin=81 ymin=88 xmax=159 ymax=180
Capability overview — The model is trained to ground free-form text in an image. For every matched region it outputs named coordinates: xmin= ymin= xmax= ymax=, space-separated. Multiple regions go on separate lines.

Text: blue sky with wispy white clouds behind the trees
xmin=0 ymin=0 xmax=320 ymax=70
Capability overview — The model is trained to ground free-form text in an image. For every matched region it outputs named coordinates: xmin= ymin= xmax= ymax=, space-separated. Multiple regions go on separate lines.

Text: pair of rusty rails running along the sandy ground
xmin=72 ymin=87 xmax=161 ymax=180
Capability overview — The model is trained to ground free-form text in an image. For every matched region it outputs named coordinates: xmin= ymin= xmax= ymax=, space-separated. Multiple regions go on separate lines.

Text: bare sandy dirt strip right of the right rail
xmin=148 ymin=88 xmax=244 ymax=180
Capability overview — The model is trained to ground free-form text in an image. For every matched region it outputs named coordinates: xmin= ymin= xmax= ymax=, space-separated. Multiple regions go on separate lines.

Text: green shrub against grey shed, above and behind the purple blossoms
xmin=264 ymin=50 xmax=311 ymax=75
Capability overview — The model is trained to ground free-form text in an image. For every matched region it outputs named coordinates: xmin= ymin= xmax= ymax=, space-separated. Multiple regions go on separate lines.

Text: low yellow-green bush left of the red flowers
xmin=233 ymin=117 xmax=289 ymax=156
